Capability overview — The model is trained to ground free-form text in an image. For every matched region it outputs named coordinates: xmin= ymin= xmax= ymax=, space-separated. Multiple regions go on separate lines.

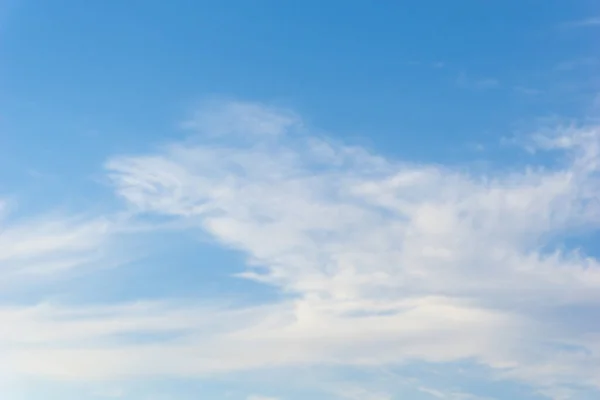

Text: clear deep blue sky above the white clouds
xmin=2 ymin=0 xmax=597 ymax=166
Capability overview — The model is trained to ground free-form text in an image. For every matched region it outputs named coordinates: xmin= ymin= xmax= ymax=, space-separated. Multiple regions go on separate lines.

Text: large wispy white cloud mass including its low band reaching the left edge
xmin=0 ymin=103 xmax=600 ymax=398
